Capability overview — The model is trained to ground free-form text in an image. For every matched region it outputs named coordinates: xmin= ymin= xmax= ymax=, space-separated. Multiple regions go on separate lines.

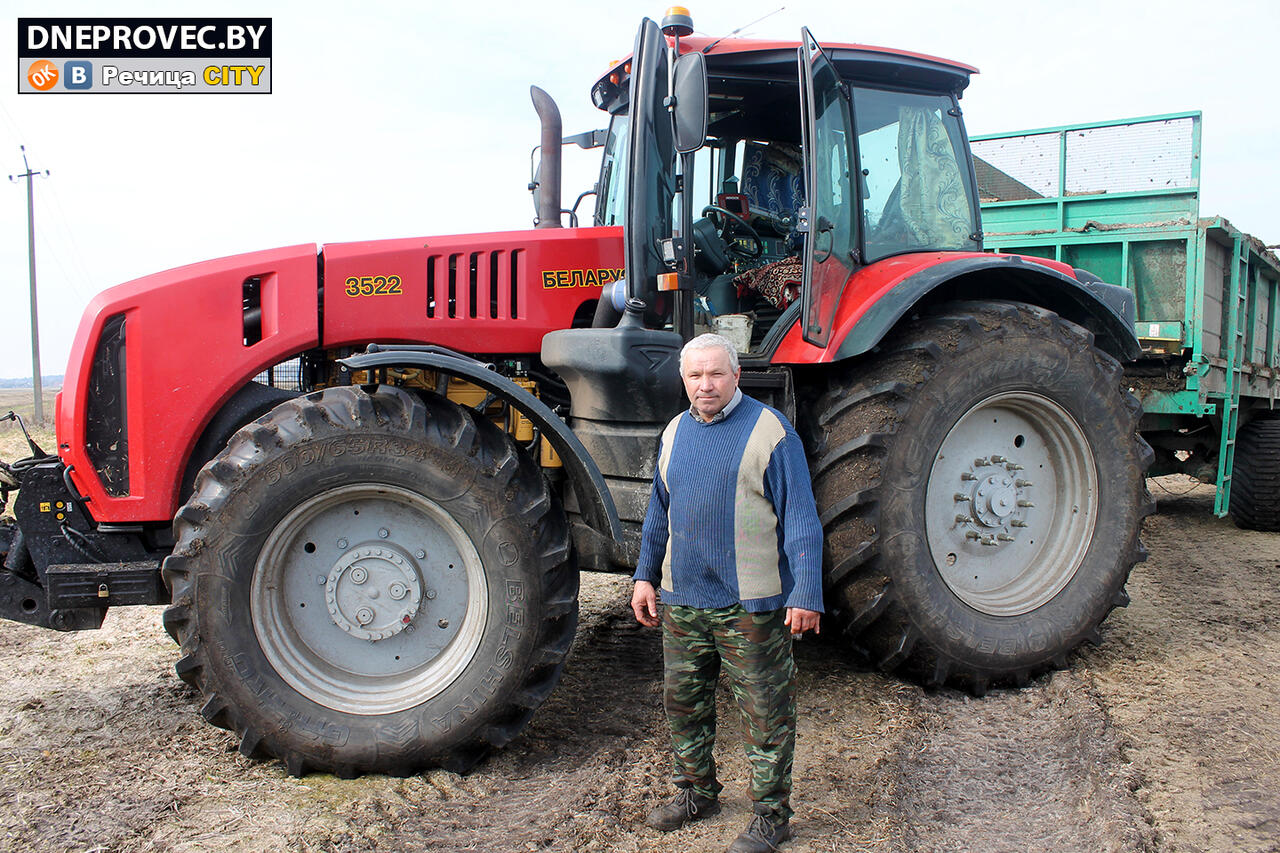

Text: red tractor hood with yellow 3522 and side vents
xmin=56 ymin=228 xmax=622 ymax=523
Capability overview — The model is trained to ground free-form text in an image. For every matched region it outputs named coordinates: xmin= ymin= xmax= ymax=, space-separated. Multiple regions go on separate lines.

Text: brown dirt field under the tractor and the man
xmin=0 ymin=476 xmax=1280 ymax=852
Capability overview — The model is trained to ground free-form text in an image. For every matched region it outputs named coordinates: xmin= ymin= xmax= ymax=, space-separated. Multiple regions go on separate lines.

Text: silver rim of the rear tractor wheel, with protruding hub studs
xmin=925 ymin=392 xmax=1098 ymax=616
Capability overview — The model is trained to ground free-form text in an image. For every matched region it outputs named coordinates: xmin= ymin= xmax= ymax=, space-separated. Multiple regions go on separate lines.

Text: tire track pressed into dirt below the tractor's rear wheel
xmin=876 ymin=671 xmax=1156 ymax=852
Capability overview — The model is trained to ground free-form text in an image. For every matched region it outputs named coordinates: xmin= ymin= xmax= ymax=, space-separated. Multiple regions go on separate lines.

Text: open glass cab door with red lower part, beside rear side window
xmin=799 ymin=28 xmax=859 ymax=347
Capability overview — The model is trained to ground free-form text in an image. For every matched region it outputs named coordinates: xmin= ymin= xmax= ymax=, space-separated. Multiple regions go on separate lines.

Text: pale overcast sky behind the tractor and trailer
xmin=0 ymin=0 xmax=1280 ymax=377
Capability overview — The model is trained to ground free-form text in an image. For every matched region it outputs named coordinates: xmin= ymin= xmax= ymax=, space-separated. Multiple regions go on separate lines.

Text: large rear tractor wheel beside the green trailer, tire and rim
xmin=810 ymin=302 xmax=1155 ymax=694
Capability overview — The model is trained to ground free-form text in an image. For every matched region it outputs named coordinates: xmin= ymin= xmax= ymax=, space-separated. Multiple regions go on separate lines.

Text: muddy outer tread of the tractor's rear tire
xmin=803 ymin=301 xmax=1157 ymax=695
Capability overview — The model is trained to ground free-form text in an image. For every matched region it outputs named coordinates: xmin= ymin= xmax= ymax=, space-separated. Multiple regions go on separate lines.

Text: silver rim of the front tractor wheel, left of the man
xmin=250 ymin=484 xmax=488 ymax=715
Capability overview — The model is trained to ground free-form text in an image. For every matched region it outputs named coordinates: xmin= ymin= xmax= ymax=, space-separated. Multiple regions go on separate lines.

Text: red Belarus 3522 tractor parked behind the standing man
xmin=0 ymin=13 xmax=1152 ymax=776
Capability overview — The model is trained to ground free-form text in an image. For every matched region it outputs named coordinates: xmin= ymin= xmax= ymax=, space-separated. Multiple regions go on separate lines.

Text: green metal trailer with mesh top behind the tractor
xmin=972 ymin=113 xmax=1280 ymax=530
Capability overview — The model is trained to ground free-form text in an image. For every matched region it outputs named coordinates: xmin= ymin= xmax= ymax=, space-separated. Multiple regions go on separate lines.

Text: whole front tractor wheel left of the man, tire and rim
xmin=163 ymin=387 xmax=577 ymax=776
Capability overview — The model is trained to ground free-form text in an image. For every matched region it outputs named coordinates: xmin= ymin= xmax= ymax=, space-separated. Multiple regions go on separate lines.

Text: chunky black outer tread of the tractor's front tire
xmin=161 ymin=387 xmax=577 ymax=779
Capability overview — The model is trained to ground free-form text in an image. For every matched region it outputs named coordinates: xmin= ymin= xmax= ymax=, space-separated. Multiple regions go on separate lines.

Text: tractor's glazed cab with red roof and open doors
xmin=591 ymin=15 xmax=982 ymax=357
